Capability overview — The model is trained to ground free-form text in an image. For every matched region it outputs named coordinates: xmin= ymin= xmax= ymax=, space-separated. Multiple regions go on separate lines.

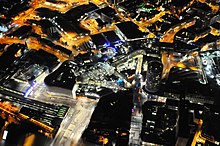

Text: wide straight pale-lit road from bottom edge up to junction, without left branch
xmin=51 ymin=99 xmax=98 ymax=146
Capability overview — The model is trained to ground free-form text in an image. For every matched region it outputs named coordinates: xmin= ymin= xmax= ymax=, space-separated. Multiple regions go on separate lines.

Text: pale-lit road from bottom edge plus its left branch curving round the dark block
xmin=28 ymin=74 xmax=98 ymax=146
